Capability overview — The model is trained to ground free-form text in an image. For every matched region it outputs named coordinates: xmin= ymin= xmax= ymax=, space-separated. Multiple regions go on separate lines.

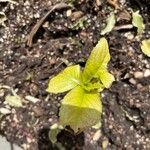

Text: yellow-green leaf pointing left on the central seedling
xmin=47 ymin=65 xmax=81 ymax=93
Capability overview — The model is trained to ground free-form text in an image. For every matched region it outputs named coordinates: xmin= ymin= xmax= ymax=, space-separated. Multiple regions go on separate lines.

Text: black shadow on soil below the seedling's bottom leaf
xmin=38 ymin=128 xmax=84 ymax=150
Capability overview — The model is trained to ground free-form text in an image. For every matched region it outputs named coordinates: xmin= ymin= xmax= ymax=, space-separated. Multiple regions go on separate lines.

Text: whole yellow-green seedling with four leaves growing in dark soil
xmin=47 ymin=38 xmax=114 ymax=133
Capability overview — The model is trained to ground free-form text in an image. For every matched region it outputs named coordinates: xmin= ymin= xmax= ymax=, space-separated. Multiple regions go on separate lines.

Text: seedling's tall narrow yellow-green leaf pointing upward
xmin=82 ymin=38 xmax=110 ymax=83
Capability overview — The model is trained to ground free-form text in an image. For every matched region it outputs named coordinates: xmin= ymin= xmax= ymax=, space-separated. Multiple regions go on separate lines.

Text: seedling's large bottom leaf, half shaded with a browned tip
xmin=59 ymin=86 xmax=102 ymax=133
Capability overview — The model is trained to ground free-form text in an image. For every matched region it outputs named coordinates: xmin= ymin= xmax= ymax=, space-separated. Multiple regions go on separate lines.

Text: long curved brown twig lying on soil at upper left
xmin=27 ymin=3 xmax=71 ymax=47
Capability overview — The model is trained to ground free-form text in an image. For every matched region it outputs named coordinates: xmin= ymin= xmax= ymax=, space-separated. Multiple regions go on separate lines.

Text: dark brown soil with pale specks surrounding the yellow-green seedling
xmin=0 ymin=0 xmax=150 ymax=150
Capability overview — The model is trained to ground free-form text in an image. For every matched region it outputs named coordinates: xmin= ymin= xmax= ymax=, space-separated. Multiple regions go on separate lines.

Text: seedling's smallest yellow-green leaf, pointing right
xmin=96 ymin=69 xmax=115 ymax=88
